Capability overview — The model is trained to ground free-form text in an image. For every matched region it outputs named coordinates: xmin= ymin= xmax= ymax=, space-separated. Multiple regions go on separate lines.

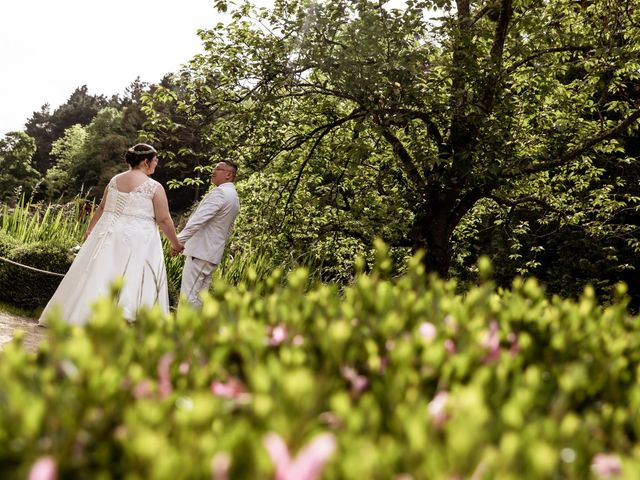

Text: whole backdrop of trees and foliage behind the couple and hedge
xmin=0 ymin=0 xmax=640 ymax=308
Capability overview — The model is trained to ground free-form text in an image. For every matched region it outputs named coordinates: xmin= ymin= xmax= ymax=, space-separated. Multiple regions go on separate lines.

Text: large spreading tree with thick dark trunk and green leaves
xmin=148 ymin=0 xmax=640 ymax=275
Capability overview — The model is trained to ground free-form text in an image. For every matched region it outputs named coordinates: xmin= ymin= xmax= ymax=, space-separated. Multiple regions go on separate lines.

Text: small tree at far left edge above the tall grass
xmin=0 ymin=132 xmax=38 ymax=202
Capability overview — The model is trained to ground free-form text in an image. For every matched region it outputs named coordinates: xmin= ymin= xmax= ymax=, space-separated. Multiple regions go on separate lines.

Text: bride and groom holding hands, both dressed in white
xmin=39 ymin=143 xmax=240 ymax=325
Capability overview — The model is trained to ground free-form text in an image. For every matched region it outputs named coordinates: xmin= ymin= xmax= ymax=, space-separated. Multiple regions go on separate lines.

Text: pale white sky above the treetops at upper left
xmin=0 ymin=0 xmax=222 ymax=138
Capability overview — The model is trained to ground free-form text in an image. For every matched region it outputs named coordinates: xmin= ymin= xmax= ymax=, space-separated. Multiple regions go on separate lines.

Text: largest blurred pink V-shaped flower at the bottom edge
xmin=263 ymin=432 xmax=336 ymax=480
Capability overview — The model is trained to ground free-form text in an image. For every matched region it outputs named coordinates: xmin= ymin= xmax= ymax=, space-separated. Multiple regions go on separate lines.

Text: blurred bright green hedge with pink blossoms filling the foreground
xmin=0 ymin=253 xmax=640 ymax=480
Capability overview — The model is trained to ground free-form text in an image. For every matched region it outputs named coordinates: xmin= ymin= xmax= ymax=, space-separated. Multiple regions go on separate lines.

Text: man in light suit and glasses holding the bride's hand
xmin=171 ymin=160 xmax=240 ymax=308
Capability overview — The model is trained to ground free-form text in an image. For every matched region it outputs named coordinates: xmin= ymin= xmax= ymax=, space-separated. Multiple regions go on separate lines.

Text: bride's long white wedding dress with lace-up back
xmin=39 ymin=175 xmax=169 ymax=325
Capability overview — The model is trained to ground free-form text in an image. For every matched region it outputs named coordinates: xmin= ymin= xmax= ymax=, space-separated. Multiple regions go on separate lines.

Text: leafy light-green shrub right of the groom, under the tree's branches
xmin=234 ymin=127 xmax=412 ymax=283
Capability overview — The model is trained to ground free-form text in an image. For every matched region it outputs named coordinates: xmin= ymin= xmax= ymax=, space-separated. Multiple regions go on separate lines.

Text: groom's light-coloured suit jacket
xmin=178 ymin=182 xmax=240 ymax=265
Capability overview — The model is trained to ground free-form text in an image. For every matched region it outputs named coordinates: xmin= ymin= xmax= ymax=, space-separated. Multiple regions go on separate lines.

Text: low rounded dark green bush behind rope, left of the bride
xmin=0 ymin=240 xmax=72 ymax=309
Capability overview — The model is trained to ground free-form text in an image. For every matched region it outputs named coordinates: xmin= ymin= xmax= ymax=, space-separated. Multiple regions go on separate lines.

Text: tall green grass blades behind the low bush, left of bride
xmin=0 ymin=197 xmax=93 ymax=245
